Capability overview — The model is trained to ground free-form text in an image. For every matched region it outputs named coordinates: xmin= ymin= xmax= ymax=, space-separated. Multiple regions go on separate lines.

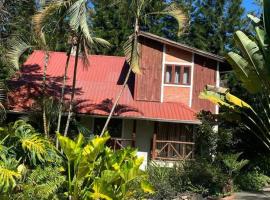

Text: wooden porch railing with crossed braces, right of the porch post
xmin=152 ymin=135 xmax=195 ymax=161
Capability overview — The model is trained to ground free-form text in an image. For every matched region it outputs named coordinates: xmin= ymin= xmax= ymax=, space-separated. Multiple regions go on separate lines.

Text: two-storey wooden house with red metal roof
xmin=6 ymin=32 xmax=225 ymax=160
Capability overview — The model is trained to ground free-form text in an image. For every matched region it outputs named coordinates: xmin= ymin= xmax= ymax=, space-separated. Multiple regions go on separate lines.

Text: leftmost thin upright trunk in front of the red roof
xmin=42 ymin=50 xmax=49 ymax=137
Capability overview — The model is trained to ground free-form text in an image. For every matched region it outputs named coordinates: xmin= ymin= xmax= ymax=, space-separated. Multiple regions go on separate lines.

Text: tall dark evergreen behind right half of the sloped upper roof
xmin=179 ymin=0 xmax=244 ymax=55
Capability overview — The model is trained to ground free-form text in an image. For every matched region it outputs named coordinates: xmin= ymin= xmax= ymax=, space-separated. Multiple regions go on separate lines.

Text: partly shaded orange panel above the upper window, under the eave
xmin=165 ymin=46 xmax=192 ymax=64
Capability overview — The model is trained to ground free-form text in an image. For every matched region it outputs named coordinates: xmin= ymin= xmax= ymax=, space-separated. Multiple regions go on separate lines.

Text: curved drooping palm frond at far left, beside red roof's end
xmin=6 ymin=38 xmax=32 ymax=70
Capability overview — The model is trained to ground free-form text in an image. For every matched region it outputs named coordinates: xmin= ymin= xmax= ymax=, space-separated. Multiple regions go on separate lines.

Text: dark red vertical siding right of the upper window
xmin=192 ymin=55 xmax=217 ymax=113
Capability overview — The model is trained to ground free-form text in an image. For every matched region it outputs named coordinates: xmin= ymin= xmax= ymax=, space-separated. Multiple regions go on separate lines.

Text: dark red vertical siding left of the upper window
xmin=134 ymin=38 xmax=163 ymax=102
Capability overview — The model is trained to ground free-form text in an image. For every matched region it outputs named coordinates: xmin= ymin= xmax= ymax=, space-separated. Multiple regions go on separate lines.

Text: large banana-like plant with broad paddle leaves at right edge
xmin=200 ymin=0 xmax=270 ymax=149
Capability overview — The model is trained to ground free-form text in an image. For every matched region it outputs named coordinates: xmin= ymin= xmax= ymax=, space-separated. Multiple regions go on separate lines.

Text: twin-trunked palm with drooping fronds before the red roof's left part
xmin=32 ymin=0 xmax=109 ymax=138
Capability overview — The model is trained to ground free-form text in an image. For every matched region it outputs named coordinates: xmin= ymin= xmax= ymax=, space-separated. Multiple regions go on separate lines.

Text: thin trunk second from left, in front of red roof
xmin=56 ymin=45 xmax=72 ymax=149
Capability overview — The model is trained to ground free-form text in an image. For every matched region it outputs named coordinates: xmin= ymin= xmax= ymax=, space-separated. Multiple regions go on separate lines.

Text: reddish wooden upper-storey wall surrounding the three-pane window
xmin=134 ymin=37 xmax=217 ymax=113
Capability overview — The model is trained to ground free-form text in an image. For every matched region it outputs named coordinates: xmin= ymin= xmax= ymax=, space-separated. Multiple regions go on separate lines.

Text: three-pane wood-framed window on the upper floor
xmin=164 ymin=65 xmax=191 ymax=85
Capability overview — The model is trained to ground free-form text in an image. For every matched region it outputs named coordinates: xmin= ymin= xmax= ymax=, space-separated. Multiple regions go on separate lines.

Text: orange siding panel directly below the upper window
xmin=163 ymin=86 xmax=190 ymax=106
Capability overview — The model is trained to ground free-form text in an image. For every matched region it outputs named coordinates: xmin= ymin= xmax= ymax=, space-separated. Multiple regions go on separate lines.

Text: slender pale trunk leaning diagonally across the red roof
xmin=100 ymin=18 xmax=139 ymax=137
